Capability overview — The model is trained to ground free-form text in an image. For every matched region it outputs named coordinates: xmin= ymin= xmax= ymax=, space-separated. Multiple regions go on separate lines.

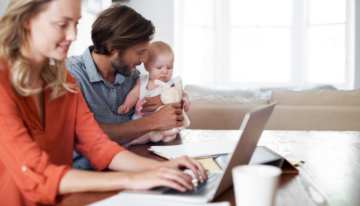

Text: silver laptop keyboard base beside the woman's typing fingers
xmin=163 ymin=173 xmax=223 ymax=195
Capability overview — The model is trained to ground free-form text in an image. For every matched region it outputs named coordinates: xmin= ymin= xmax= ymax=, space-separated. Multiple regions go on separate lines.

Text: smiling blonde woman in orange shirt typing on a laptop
xmin=0 ymin=0 xmax=206 ymax=205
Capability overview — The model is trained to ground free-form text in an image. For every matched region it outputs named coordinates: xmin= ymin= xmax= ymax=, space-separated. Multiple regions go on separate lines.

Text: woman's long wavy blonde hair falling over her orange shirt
xmin=0 ymin=0 xmax=76 ymax=99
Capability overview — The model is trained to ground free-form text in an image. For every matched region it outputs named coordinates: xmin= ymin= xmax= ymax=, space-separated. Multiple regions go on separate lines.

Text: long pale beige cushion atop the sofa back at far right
xmin=270 ymin=89 xmax=360 ymax=106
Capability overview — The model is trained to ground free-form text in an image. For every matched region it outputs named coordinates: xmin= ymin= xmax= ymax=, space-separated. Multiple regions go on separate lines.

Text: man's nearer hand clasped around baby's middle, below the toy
xmin=146 ymin=103 xmax=184 ymax=131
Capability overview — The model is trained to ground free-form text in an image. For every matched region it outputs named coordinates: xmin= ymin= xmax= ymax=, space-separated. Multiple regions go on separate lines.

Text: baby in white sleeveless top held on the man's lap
xmin=117 ymin=41 xmax=190 ymax=144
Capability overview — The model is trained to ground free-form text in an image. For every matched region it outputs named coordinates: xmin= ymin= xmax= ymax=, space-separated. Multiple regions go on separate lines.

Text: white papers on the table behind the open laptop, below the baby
xmin=149 ymin=140 xmax=236 ymax=159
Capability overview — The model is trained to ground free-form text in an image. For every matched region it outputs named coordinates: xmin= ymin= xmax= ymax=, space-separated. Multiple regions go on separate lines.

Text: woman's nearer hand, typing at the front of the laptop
xmin=127 ymin=167 xmax=194 ymax=192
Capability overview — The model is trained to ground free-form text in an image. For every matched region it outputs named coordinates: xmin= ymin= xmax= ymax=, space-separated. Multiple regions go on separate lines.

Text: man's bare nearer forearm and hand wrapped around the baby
xmin=99 ymin=103 xmax=184 ymax=144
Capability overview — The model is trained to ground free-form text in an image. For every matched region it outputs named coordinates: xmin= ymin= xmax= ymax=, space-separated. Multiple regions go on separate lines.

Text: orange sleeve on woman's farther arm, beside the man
xmin=75 ymin=82 xmax=125 ymax=171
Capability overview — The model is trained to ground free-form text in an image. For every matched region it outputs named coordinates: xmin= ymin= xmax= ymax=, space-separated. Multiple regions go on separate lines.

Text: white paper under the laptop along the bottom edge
xmin=88 ymin=193 xmax=230 ymax=206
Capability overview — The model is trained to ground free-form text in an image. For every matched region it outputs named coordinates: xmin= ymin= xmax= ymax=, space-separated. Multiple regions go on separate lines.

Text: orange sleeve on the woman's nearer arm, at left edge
xmin=0 ymin=76 xmax=71 ymax=204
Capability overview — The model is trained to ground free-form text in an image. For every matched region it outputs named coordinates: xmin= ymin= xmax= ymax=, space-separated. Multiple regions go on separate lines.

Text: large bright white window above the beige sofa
xmin=174 ymin=0 xmax=353 ymax=89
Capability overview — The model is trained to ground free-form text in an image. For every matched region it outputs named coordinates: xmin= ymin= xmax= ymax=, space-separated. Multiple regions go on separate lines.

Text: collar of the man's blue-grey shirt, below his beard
xmin=83 ymin=46 xmax=126 ymax=85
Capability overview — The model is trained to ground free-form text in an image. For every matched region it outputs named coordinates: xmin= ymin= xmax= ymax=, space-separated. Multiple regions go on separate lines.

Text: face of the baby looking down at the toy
xmin=147 ymin=52 xmax=174 ymax=82
